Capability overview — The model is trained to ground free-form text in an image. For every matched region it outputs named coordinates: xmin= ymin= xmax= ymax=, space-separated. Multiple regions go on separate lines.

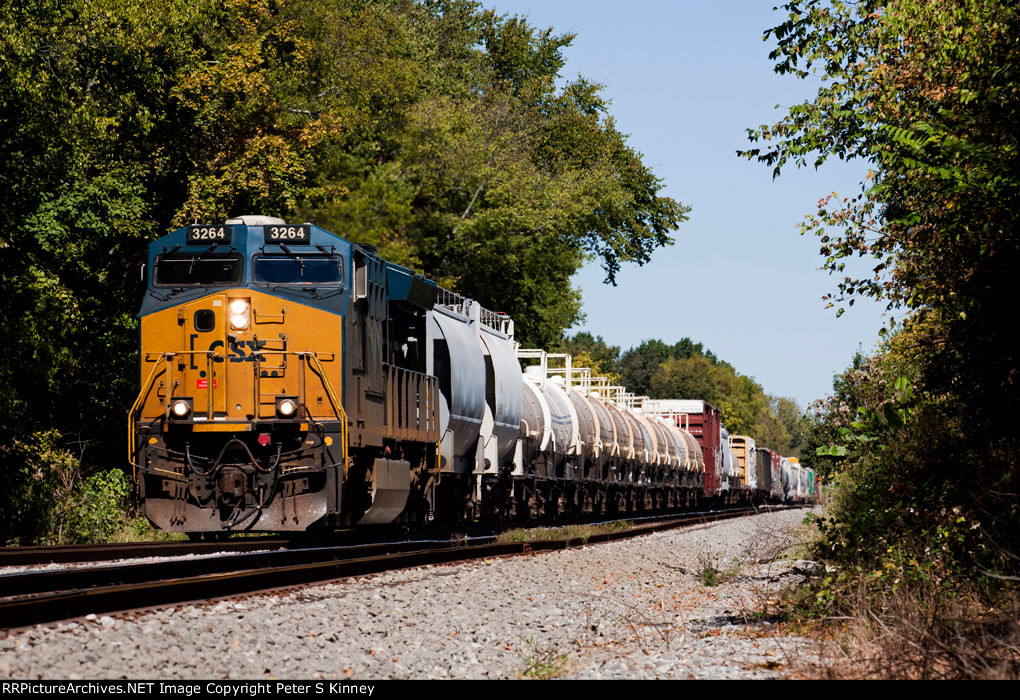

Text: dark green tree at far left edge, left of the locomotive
xmin=0 ymin=2 xmax=207 ymax=461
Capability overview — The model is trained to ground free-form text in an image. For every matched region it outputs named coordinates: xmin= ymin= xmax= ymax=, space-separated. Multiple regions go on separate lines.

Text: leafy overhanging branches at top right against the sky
xmin=745 ymin=0 xmax=1020 ymax=328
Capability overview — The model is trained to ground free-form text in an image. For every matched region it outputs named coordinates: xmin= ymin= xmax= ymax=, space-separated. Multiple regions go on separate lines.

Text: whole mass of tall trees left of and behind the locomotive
xmin=0 ymin=0 xmax=687 ymax=539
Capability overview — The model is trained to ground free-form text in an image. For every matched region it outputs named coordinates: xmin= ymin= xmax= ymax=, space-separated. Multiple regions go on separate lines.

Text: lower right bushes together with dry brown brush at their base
xmin=794 ymin=328 xmax=1020 ymax=679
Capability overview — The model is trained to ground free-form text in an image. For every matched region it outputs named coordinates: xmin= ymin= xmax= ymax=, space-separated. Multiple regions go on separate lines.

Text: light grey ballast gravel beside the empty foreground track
xmin=0 ymin=510 xmax=811 ymax=680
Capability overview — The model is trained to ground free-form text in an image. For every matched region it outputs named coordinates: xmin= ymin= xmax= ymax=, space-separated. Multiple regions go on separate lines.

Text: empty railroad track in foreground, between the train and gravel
xmin=0 ymin=506 xmax=783 ymax=630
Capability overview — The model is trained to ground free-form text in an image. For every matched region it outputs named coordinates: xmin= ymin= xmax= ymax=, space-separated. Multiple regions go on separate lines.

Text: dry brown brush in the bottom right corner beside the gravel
xmin=796 ymin=530 xmax=1020 ymax=680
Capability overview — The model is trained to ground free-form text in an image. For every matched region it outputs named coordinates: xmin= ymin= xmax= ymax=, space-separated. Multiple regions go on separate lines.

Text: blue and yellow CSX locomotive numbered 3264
xmin=129 ymin=216 xmax=440 ymax=533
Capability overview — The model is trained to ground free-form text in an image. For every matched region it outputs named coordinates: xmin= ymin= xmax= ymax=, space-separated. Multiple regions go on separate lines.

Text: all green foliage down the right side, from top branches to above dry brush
xmin=744 ymin=0 xmax=1020 ymax=593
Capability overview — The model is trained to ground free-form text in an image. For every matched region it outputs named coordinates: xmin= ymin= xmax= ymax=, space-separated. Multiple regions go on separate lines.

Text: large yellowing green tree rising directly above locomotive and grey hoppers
xmin=176 ymin=0 xmax=687 ymax=346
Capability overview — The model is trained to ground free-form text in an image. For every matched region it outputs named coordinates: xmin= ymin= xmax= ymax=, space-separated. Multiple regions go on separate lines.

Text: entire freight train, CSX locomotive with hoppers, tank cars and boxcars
xmin=129 ymin=216 xmax=816 ymax=534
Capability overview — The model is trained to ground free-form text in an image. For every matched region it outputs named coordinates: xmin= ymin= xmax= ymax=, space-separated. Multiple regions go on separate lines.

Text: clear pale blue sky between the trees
xmin=483 ymin=0 xmax=884 ymax=408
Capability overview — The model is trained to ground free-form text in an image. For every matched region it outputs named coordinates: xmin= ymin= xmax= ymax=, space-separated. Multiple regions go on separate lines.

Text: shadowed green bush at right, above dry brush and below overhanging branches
xmin=809 ymin=328 xmax=1016 ymax=614
